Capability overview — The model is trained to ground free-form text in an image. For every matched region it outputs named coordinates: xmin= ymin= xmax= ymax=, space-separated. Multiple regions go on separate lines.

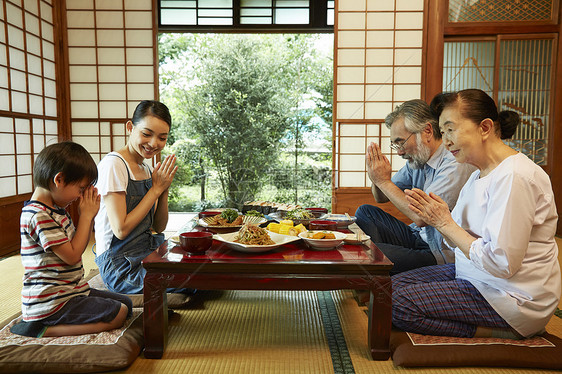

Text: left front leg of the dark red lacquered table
xmin=143 ymin=273 xmax=168 ymax=358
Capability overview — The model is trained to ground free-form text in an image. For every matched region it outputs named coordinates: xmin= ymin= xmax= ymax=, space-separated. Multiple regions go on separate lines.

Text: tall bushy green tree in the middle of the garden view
xmin=183 ymin=35 xmax=294 ymax=206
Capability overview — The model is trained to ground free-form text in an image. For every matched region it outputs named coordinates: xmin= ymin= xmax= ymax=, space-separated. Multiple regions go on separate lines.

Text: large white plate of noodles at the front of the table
xmin=213 ymin=224 xmax=300 ymax=253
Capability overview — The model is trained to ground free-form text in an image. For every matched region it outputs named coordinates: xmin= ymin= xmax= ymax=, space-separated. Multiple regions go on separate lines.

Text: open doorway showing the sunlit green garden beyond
xmin=159 ymin=33 xmax=333 ymax=211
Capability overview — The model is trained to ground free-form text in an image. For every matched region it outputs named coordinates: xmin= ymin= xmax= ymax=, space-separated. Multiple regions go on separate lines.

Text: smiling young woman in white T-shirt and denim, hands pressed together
xmin=95 ymin=100 xmax=177 ymax=294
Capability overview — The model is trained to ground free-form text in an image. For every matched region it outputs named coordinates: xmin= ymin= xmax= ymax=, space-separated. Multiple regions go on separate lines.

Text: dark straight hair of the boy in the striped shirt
xmin=33 ymin=141 xmax=98 ymax=190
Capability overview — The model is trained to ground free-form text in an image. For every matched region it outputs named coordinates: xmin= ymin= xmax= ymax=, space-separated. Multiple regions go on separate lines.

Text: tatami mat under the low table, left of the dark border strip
xmin=119 ymin=291 xmax=334 ymax=373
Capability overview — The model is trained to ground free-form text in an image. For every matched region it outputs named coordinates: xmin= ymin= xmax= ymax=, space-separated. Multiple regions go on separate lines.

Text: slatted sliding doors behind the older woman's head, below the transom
xmin=443 ymin=36 xmax=554 ymax=165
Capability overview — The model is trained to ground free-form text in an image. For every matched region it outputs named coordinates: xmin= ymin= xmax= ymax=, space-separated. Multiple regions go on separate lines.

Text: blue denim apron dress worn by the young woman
xmin=95 ymin=155 xmax=164 ymax=294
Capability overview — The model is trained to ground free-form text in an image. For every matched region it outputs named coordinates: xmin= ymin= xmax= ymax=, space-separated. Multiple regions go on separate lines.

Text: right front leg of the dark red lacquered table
xmin=367 ymin=276 xmax=392 ymax=360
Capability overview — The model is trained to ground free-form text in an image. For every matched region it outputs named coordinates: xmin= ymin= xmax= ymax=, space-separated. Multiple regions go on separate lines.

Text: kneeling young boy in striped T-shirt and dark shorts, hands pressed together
xmin=11 ymin=142 xmax=132 ymax=337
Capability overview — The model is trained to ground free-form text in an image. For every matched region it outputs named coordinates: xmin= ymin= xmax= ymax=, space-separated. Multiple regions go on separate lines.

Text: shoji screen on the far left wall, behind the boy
xmin=0 ymin=0 xmax=59 ymax=199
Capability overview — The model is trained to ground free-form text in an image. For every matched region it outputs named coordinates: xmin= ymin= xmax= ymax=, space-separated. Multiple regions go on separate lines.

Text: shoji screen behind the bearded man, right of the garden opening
xmin=333 ymin=0 xmax=424 ymax=213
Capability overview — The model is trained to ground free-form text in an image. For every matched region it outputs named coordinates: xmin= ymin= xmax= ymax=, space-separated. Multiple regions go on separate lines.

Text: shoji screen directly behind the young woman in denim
xmin=66 ymin=0 xmax=158 ymax=162
